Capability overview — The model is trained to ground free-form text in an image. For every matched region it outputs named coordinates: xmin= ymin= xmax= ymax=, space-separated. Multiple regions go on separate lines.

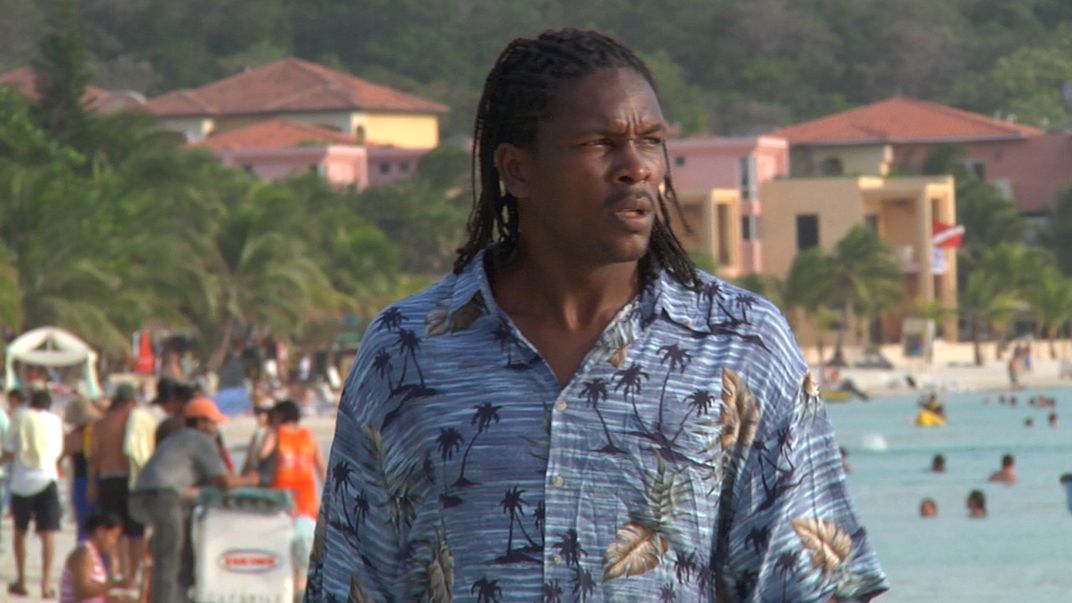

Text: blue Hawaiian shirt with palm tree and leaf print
xmin=307 ymin=251 xmax=888 ymax=603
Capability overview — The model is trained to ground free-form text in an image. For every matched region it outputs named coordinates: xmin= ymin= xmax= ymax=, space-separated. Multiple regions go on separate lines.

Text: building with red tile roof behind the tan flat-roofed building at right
xmin=770 ymin=97 xmax=1072 ymax=215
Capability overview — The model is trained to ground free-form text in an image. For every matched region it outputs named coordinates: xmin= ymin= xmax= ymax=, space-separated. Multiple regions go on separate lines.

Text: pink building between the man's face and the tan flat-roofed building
xmin=667 ymin=136 xmax=789 ymax=275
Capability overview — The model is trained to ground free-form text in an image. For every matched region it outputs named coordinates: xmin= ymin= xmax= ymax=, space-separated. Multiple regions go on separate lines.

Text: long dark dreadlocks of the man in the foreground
xmin=453 ymin=29 xmax=701 ymax=289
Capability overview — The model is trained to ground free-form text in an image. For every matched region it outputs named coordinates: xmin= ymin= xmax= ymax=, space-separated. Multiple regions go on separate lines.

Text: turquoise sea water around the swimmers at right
xmin=828 ymin=389 xmax=1072 ymax=603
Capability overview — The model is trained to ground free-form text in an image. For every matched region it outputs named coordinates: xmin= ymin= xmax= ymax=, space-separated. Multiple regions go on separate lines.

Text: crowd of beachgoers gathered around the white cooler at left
xmin=0 ymin=356 xmax=326 ymax=603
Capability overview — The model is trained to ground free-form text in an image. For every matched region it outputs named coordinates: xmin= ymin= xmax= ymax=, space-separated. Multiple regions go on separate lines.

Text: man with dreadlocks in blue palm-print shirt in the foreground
xmin=307 ymin=30 xmax=887 ymax=602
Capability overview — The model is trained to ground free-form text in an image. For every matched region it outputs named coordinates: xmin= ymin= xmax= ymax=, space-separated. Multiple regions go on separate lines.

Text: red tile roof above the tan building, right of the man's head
xmin=769 ymin=97 xmax=1043 ymax=145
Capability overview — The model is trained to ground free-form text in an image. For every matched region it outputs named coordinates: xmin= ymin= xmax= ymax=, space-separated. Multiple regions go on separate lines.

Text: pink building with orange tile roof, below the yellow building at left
xmin=190 ymin=119 xmax=430 ymax=191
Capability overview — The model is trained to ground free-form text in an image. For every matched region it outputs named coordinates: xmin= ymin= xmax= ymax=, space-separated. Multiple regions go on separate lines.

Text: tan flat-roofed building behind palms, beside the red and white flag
xmin=760 ymin=176 xmax=957 ymax=343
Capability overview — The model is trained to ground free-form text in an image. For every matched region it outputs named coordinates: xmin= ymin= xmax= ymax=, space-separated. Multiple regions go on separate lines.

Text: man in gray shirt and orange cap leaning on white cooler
xmin=130 ymin=398 xmax=256 ymax=603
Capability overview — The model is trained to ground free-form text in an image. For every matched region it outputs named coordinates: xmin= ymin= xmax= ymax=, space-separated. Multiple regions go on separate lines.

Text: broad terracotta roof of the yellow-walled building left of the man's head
xmin=147 ymin=58 xmax=450 ymax=116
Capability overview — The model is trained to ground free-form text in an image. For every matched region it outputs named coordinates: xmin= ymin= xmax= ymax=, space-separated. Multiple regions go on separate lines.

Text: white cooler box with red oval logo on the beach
xmin=193 ymin=489 xmax=294 ymax=603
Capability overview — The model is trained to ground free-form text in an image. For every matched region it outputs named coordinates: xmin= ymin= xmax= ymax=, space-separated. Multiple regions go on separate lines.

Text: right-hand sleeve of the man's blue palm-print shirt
xmin=716 ymin=309 xmax=889 ymax=602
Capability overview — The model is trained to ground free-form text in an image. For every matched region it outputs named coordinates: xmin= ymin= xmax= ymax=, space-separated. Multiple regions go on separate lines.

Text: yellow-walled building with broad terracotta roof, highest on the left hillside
xmin=146 ymin=58 xmax=449 ymax=149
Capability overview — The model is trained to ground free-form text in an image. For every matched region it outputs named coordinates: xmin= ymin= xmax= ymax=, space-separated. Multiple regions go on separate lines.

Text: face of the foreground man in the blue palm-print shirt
xmin=501 ymin=69 xmax=667 ymax=267
